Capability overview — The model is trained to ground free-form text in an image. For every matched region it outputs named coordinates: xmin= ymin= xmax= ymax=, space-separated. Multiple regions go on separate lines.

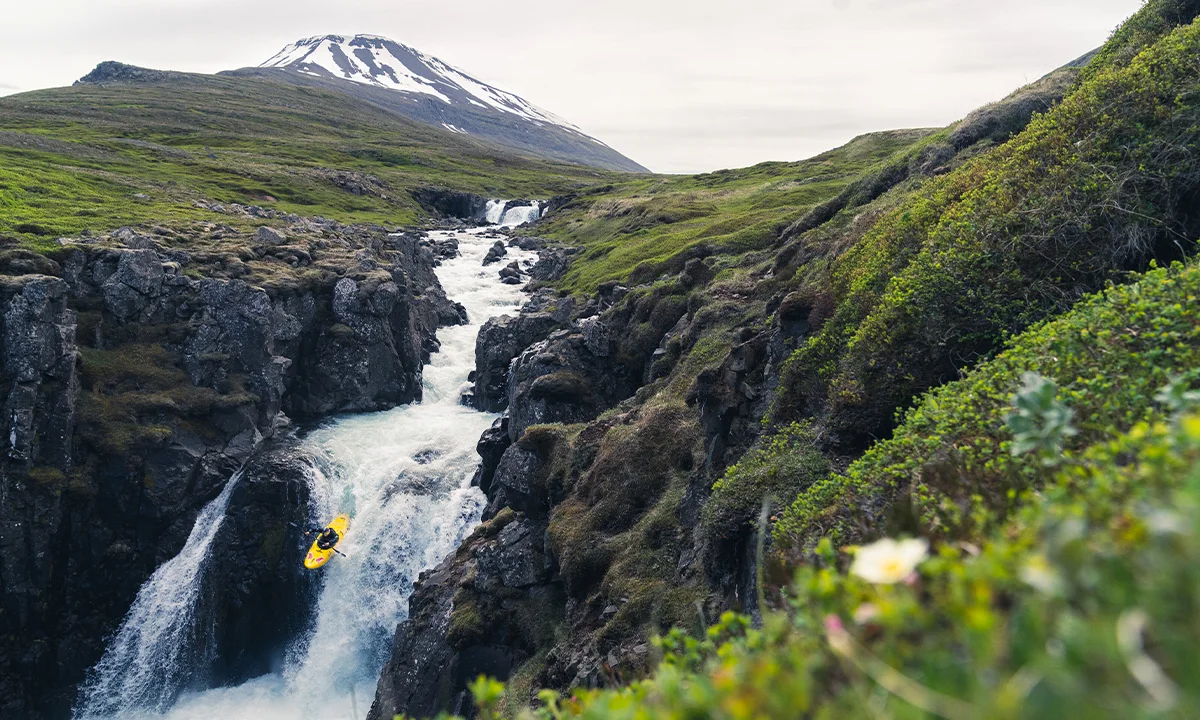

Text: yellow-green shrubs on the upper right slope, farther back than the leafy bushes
xmin=774 ymin=16 xmax=1200 ymax=448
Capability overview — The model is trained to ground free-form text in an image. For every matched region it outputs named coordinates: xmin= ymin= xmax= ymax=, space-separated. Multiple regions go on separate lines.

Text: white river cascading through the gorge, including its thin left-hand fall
xmin=77 ymin=226 xmax=536 ymax=720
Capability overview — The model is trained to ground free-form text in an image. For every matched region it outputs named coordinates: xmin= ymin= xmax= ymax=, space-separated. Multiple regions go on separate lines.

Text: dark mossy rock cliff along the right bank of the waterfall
xmin=370 ymin=238 xmax=777 ymax=720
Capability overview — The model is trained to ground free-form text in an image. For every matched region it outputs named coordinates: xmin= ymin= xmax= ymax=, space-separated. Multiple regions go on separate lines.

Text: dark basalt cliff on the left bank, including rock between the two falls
xmin=0 ymin=218 xmax=453 ymax=718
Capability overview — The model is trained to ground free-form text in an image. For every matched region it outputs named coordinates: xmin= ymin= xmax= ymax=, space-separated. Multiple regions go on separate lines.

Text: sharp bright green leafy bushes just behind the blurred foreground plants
xmin=776 ymin=263 xmax=1200 ymax=547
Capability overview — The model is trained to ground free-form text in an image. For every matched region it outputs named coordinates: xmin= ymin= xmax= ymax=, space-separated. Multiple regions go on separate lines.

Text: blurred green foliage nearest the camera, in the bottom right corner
xmin=458 ymin=415 xmax=1200 ymax=720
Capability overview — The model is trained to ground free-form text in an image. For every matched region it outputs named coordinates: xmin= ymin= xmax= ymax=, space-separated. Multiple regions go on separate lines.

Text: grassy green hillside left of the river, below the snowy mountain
xmin=0 ymin=73 xmax=607 ymax=246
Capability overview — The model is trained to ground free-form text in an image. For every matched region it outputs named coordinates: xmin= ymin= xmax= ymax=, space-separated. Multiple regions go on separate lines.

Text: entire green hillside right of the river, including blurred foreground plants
xmin=446 ymin=0 xmax=1200 ymax=720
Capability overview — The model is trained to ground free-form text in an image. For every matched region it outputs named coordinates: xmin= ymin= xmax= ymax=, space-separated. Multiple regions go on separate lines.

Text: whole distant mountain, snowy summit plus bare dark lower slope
xmin=224 ymin=35 xmax=648 ymax=173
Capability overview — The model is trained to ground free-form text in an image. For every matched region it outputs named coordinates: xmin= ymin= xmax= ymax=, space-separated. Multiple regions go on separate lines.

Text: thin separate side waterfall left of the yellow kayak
xmin=76 ymin=470 xmax=241 ymax=718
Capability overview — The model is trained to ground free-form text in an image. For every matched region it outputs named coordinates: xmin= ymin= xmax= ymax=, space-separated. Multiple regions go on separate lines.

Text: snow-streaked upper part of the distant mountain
xmin=259 ymin=35 xmax=582 ymax=134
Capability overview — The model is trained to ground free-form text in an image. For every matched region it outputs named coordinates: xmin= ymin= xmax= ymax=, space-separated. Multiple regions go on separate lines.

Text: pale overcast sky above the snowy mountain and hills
xmin=0 ymin=0 xmax=1141 ymax=173
